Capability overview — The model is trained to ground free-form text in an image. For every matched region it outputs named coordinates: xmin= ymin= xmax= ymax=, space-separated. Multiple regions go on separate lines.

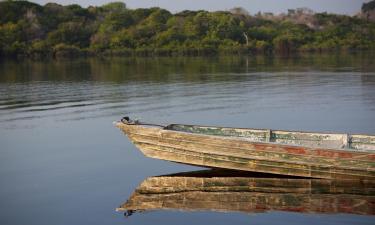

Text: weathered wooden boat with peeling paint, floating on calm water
xmin=116 ymin=117 xmax=375 ymax=179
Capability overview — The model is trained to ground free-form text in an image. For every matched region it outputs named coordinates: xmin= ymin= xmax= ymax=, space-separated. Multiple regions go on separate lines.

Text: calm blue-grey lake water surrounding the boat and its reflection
xmin=0 ymin=54 xmax=375 ymax=225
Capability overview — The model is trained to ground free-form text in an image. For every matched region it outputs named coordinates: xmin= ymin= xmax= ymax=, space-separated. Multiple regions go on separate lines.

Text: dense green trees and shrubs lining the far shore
xmin=0 ymin=0 xmax=375 ymax=57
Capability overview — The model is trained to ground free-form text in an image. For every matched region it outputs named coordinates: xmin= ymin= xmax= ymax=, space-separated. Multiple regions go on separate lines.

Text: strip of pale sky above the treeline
xmin=31 ymin=0 xmax=369 ymax=15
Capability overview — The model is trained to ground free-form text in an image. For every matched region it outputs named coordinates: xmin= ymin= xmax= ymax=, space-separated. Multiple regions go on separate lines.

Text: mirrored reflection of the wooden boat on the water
xmin=117 ymin=170 xmax=375 ymax=216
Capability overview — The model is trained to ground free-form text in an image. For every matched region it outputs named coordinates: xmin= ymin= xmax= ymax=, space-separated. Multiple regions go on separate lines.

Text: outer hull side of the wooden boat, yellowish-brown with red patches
xmin=117 ymin=123 xmax=375 ymax=180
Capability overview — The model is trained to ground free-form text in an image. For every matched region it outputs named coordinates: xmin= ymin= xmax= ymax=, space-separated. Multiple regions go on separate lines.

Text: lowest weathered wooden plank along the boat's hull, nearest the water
xmin=135 ymin=143 xmax=375 ymax=179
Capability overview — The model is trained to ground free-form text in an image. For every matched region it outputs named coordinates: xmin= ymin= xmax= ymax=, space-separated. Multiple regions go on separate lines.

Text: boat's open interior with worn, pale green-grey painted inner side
xmin=164 ymin=124 xmax=375 ymax=152
